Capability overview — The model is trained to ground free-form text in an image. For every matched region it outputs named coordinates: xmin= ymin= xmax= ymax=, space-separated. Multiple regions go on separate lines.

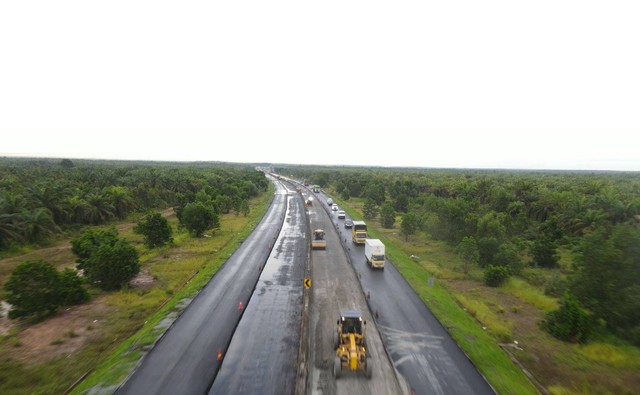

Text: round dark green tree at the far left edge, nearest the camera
xmin=4 ymin=260 xmax=60 ymax=319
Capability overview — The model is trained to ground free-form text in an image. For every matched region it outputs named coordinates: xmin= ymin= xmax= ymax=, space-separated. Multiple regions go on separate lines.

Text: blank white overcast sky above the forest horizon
xmin=0 ymin=0 xmax=640 ymax=171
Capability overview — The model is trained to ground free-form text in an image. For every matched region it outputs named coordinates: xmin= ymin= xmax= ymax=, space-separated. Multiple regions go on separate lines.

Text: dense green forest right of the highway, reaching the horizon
xmin=284 ymin=167 xmax=640 ymax=345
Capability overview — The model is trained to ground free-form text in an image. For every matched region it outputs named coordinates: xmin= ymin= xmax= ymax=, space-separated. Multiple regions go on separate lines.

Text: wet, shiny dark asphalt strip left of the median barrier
xmin=209 ymin=186 xmax=309 ymax=395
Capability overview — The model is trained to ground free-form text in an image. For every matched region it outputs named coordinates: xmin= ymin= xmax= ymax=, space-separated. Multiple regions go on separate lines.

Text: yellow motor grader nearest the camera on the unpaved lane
xmin=333 ymin=309 xmax=373 ymax=378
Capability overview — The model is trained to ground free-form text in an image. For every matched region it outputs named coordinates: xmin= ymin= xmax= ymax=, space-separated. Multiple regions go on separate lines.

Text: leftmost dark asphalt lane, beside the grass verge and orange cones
xmin=116 ymin=182 xmax=288 ymax=395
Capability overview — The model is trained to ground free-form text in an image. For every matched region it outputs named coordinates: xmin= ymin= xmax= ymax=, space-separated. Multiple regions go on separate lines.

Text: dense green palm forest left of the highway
xmin=0 ymin=158 xmax=268 ymax=252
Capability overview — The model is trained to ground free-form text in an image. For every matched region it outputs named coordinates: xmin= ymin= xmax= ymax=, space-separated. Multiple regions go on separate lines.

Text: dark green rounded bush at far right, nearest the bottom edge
xmin=542 ymin=295 xmax=592 ymax=343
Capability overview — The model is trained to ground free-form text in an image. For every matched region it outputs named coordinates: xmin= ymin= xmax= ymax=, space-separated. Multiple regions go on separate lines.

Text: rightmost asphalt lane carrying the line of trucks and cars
xmin=316 ymin=190 xmax=495 ymax=395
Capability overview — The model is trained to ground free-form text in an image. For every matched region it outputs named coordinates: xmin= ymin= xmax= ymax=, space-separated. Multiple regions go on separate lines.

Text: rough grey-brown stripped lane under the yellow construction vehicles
xmin=305 ymin=190 xmax=408 ymax=395
